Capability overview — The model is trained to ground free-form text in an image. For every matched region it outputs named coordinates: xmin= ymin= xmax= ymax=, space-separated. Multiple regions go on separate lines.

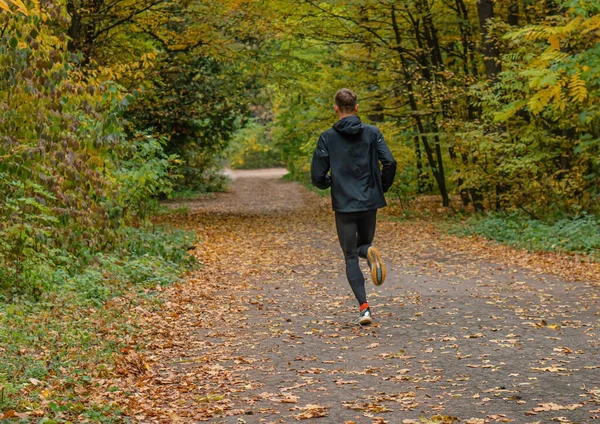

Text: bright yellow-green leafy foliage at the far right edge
xmin=450 ymin=2 xmax=600 ymax=217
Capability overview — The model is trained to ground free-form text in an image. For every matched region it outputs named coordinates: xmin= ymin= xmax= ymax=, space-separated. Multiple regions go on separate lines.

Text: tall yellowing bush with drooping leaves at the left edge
xmin=0 ymin=5 xmax=124 ymax=293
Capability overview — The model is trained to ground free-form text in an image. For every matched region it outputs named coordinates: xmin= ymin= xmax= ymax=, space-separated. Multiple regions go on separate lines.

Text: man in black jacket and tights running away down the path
xmin=311 ymin=88 xmax=396 ymax=325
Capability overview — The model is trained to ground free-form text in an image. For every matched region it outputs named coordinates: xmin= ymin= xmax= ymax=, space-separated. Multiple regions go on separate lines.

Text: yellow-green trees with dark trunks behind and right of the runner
xmin=271 ymin=0 xmax=600 ymax=222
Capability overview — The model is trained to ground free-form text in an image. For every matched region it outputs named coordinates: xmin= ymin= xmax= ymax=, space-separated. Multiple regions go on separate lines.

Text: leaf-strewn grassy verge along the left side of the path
xmin=0 ymin=228 xmax=195 ymax=423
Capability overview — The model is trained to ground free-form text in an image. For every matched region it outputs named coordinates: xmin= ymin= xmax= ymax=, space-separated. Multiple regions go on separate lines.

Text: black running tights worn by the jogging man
xmin=335 ymin=209 xmax=377 ymax=305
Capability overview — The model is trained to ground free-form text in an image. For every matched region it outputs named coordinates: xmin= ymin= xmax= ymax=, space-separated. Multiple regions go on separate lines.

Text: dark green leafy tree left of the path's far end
xmin=127 ymin=53 xmax=245 ymax=190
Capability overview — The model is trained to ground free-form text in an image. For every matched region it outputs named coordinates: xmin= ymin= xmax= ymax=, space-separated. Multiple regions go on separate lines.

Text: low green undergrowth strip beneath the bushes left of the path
xmin=0 ymin=222 xmax=196 ymax=303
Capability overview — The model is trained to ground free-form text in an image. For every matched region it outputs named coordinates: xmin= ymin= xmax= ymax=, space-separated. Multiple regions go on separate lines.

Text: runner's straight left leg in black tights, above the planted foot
xmin=335 ymin=212 xmax=367 ymax=306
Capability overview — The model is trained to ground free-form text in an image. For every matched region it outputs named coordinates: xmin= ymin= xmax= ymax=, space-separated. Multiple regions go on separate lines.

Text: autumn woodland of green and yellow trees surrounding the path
xmin=0 ymin=0 xmax=600 ymax=420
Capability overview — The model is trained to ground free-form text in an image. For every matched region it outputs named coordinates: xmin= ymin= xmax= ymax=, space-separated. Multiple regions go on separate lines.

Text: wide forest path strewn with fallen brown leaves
xmin=110 ymin=173 xmax=600 ymax=424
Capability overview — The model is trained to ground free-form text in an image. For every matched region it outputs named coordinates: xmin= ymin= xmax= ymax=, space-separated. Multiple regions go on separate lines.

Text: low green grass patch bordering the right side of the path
xmin=448 ymin=213 xmax=600 ymax=258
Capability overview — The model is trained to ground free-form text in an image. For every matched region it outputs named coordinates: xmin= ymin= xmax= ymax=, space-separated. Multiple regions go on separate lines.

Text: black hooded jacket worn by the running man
xmin=311 ymin=116 xmax=396 ymax=212
